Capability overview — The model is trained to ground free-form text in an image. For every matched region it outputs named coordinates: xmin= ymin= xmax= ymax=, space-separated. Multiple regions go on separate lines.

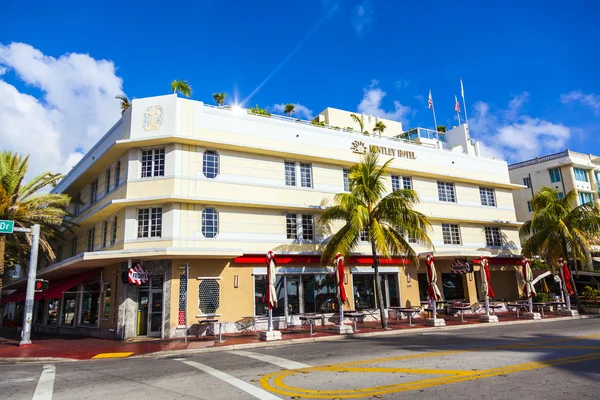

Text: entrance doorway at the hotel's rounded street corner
xmin=137 ymin=276 xmax=163 ymax=337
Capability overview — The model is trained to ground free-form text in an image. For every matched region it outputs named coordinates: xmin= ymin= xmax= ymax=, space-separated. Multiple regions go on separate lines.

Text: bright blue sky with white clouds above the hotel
xmin=0 ymin=0 xmax=600 ymax=175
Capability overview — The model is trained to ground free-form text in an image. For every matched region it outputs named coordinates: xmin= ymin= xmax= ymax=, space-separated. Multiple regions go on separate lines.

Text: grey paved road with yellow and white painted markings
xmin=0 ymin=319 xmax=600 ymax=400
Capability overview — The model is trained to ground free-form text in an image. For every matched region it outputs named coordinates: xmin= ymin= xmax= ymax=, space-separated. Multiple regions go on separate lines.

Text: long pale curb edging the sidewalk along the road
xmin=0 ymin=314 xmax=600 ymax=364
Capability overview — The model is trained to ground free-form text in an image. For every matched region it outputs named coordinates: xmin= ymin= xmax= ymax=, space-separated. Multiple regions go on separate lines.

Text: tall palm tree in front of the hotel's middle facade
xmin=320 ymin=151 xmax=433 ymax=329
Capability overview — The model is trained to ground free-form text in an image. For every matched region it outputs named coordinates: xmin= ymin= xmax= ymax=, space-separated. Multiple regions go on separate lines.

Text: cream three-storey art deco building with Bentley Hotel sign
xmin=0 ymin=95 xmax=522 ymax=339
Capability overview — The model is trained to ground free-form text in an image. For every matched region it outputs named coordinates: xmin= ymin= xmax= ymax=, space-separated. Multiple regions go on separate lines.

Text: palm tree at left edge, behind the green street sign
xmin=0 ymin=151 xmax=70 ymax=291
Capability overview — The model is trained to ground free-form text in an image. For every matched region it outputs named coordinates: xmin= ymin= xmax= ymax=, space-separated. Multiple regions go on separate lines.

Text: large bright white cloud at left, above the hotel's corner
xmin=0 ymin=43 xmax=122 ymax=176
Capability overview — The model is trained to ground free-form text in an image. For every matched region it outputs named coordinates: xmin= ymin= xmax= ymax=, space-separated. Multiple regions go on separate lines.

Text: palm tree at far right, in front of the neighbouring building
xmin=519 ymin=187 xmax=600 ymax=311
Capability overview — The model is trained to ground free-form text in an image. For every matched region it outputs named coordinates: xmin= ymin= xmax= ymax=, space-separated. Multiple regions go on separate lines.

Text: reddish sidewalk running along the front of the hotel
xmin=0 ymin=313 xmax=590 ymax=362
